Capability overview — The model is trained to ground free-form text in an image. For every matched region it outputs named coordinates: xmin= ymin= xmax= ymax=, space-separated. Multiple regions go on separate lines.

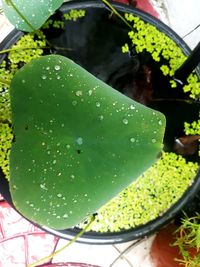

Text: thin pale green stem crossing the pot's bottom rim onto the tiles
xmin=27 ymin=215 xmax=95 ymax=267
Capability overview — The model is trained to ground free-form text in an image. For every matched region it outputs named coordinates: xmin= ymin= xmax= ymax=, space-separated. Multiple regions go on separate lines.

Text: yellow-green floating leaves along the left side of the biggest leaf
xmin=0 ymin=31 xmax=46 ymax=179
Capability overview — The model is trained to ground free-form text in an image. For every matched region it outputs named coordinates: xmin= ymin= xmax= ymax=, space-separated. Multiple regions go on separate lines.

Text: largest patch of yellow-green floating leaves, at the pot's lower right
xmin=81 ymin=152 xmax=198 ymax=232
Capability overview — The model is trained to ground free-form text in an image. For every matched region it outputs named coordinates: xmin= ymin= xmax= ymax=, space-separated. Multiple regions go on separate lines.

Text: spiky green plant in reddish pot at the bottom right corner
xmin=173 ymin=214 xmax=200 ymax=267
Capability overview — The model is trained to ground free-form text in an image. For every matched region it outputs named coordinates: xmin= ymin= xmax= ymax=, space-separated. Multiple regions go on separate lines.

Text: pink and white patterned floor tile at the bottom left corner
xmin=0 ymin=201 xmax=58 ymax=267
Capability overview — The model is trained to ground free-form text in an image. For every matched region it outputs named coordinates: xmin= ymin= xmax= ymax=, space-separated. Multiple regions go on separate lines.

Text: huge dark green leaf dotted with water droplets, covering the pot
xmin=10 ymin=55 xmax=165 ymax=229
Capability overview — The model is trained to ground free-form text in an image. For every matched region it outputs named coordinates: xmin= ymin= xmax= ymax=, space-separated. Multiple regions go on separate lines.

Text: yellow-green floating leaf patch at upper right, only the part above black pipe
xmin=122 ymin=14 xmax=186 ymax=76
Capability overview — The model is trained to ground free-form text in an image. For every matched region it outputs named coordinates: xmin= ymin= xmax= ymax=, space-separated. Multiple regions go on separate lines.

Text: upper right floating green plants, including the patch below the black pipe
xmin=122 ymin=14 xmax=200 ymax=100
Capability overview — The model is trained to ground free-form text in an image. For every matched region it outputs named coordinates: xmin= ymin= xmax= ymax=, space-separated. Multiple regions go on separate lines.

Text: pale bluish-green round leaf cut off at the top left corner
xmin=3 ymin=0 xmax=63 ymax=32
